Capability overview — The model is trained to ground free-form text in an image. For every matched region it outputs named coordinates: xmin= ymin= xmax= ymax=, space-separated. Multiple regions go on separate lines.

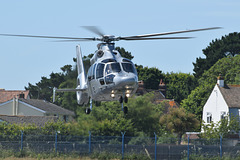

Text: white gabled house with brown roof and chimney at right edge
xmin=202 ymin=76 xmax=240 ymax=124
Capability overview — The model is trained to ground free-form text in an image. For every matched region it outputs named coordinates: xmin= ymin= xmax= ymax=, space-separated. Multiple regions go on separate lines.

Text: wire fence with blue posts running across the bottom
xmin=0 ymin=132 xmax=240 ymax=159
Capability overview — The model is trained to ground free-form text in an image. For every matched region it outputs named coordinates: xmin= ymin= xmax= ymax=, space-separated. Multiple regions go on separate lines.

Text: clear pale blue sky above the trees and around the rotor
xmin=0 ymin=0 xmax=240 ymax=90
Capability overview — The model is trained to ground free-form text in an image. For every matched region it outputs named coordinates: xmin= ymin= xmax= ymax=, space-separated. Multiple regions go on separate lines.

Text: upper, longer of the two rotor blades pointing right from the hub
xmin=122 ymin=27 xmax=221 ymax=38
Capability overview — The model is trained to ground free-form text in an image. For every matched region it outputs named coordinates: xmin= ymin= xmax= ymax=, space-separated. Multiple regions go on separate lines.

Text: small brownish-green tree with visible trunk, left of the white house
xmin=159 ymin=108 xmax=200 ymax=144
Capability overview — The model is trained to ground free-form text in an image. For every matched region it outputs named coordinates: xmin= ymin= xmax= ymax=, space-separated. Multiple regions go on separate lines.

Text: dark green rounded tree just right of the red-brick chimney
xmin=164 ymin=73 xmax=197 ymax=103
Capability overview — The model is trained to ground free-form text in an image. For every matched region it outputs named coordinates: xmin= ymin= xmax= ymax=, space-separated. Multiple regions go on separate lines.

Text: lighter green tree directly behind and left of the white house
xmin=181 ymin=55 xmax=240 ymax=120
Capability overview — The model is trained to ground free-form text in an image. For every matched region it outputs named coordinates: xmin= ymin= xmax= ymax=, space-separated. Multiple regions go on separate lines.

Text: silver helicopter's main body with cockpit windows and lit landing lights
xmin=87 ymin=43 xmax=138 ymax=101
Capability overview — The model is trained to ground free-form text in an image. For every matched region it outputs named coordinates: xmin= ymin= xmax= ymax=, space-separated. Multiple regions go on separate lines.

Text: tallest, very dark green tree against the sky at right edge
xmin=193 ymin=32 xmax=240 ymax=78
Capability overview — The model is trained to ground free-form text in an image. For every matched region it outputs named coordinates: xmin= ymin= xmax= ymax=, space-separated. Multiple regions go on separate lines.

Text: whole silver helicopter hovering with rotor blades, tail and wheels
xmin=0 ymin=26 xmax=220 ymax=114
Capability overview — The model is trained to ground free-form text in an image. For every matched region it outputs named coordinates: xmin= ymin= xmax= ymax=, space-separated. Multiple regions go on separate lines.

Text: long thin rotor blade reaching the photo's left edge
xmin=0 ymin=34 xmax=96 ymax=41
